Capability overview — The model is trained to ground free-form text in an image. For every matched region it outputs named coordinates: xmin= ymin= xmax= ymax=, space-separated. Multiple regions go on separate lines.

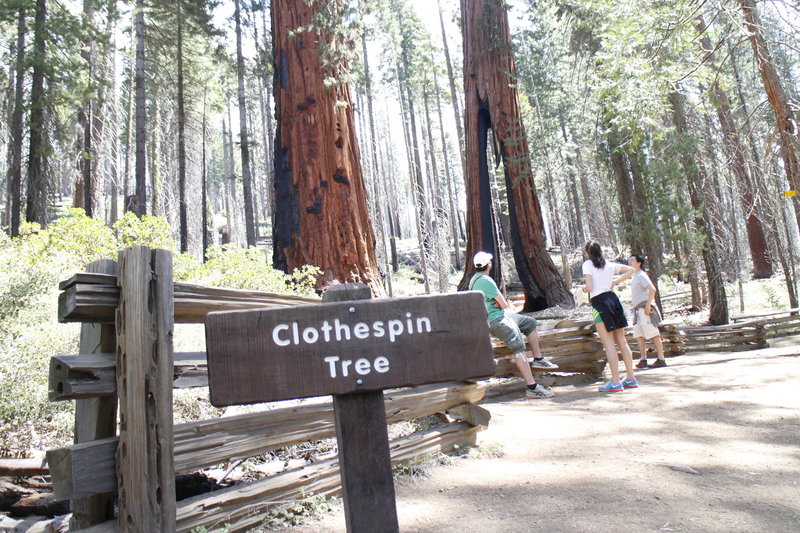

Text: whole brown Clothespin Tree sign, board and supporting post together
xmin=206 ymin=283 xmax=495 ymax=532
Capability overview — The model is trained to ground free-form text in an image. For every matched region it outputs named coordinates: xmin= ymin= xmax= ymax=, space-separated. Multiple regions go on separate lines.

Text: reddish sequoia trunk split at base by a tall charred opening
xmin=460 ymin=0 xmax=574 ymax=311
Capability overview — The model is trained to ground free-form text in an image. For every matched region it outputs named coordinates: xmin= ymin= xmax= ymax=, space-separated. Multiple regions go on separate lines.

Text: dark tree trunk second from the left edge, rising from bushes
xmin=25 ymin=0 xmax=49 ymax=227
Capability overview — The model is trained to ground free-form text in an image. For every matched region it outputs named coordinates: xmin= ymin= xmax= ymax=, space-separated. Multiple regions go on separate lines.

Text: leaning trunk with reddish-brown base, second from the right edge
xmin=696 ymin=17 xmax=772 ymax=279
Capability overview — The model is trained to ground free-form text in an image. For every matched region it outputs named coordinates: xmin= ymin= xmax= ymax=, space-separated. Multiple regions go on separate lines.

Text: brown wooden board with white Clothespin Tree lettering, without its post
xmin=206 ymin=292 xmax=495 ymax=407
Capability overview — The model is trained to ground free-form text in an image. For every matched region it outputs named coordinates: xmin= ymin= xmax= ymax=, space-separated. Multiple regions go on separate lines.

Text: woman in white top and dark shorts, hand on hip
xmin=582 ymin=242 xmax=639 ymax=392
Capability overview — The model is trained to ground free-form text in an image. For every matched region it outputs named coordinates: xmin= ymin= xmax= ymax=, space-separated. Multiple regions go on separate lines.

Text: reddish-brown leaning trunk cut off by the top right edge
xmin=739 ymin=0 xmax=800 ymax=226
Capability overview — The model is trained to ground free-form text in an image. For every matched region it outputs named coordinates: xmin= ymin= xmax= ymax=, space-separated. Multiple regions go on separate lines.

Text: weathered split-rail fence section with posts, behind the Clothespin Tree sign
xmin=47 ymin=247 xmax=490 ymax=532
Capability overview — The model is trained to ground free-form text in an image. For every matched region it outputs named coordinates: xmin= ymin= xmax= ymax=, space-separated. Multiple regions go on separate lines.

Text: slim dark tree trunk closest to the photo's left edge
xmin=7 ymin=9 xmax=26 ymax=237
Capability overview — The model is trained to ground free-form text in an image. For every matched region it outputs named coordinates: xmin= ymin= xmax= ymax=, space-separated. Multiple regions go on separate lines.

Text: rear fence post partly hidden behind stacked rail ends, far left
xmin=69 ymin=259 xmax=117 ymax=530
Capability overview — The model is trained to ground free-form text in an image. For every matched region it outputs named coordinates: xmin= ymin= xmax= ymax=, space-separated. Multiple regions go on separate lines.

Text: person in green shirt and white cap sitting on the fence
xmin=469 ymin=252 xmax=558 ymax=398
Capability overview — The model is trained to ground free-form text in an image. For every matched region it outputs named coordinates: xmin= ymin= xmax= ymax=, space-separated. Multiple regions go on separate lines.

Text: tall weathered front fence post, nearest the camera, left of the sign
xmin=116 ymin=246 xmax=176 ymax=533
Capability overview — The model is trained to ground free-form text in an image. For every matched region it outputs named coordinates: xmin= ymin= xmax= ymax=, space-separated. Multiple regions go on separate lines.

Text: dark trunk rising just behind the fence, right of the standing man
xmin=669 ymin=92 xmax=729 ymax=324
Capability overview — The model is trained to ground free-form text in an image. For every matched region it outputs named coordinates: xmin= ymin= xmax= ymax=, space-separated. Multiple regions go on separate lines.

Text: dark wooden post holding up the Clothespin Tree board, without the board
xmin=322 ymin=283 xmax=399 ymax=533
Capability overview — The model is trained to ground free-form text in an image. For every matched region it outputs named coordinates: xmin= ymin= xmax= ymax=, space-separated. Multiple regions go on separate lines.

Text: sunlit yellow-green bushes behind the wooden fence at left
xmin=0 ymin=209 xmax=320 ymax=454
